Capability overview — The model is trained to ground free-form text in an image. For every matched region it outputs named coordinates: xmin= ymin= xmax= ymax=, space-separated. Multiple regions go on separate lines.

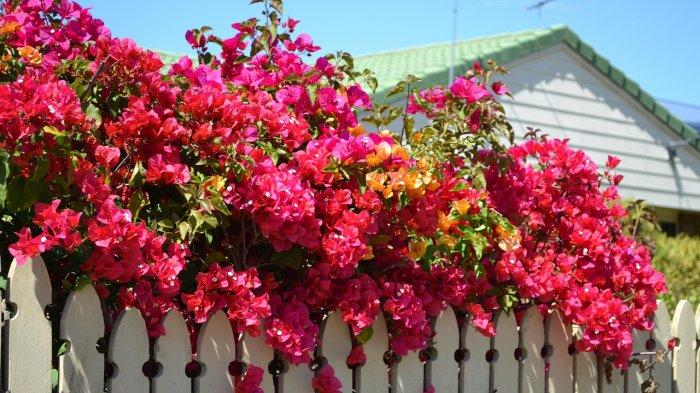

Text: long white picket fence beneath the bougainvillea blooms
xmin=0 ymin=254 xmax=700 ymax=393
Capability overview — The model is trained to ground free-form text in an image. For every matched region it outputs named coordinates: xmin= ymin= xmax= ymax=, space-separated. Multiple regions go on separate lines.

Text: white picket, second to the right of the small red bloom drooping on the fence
xmin=519 ymin=306 xmax=545 ymax=393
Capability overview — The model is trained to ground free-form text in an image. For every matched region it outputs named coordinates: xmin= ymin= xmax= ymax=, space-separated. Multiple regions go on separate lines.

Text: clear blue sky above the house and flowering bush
xmin=78 ymin=0 xmax=700 ymax=105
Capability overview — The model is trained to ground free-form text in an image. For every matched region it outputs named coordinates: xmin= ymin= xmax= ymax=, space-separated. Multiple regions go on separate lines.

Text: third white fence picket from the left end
xmin=109 ymin=308 xmax=149 ymax=393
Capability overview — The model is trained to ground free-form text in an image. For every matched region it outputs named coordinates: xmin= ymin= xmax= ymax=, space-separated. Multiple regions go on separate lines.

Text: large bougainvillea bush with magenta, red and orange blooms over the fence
xmin=0 ymin=0 xmax=664 ymax=391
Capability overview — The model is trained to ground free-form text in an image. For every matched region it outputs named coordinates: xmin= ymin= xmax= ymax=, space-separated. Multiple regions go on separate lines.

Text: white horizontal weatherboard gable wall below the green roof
xmin=503 ymin=45 xmax=700 ymax=211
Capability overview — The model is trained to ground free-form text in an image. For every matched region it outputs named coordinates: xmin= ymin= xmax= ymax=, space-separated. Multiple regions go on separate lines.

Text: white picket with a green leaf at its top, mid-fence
xmin=358 ymin=313 xmax=389 ymax=393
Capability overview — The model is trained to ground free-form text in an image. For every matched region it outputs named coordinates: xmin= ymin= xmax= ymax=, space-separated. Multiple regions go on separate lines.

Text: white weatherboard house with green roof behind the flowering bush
xmin=355 ymin=25 xmax=700 ymax=234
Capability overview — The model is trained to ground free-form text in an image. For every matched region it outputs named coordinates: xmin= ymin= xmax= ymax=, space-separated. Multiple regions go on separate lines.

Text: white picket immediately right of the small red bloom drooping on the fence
xmin=489 ymin=312 xmax=519 ymax=393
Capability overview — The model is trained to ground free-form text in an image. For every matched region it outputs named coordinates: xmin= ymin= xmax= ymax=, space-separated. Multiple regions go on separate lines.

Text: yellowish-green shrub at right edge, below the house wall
xmin=651 ymin=232 xmax=700 ymax=312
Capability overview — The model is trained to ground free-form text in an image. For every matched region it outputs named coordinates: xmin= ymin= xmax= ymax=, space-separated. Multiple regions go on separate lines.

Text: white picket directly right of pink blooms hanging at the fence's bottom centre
xmin=321 ymin=312 xmax=352 ymax=392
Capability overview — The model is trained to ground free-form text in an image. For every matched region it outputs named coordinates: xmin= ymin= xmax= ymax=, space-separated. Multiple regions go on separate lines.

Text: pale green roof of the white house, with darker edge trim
xmin=355 ymin=25 xmax=700 ymax=150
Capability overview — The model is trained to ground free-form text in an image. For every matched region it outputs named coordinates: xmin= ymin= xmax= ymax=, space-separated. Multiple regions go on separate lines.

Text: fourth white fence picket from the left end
xmin=153 ymin=309 xmax=192 ymax=393
